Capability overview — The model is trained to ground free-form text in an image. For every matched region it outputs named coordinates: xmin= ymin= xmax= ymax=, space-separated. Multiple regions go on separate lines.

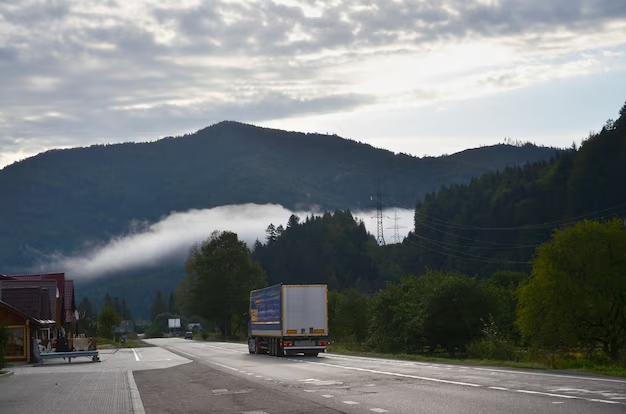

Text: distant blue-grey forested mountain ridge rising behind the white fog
xmin=0 ymin=122 xmax=558 ymax=273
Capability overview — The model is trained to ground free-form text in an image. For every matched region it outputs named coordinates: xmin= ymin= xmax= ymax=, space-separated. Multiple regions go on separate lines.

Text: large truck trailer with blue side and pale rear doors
xmin=248 ymin=284 xmax=328 ymax=357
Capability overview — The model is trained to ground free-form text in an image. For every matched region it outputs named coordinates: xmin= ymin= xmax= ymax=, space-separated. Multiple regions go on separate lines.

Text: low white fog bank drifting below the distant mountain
xmin=40 ymin=204 xmax=413 ymax=280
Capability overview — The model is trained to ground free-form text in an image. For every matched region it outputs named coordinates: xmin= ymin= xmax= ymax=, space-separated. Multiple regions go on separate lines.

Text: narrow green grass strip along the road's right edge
xmin=328 ymin=345 xmax=626 ymax=377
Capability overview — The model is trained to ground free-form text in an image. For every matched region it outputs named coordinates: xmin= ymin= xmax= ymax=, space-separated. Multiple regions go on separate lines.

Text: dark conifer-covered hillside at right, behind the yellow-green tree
xmin=404 ymin=105 xmax=626 ymax=275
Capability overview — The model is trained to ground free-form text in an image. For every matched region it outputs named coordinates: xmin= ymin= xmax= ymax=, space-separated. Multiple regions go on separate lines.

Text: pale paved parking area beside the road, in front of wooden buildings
xmin=0 ymin=347 xmax=191 ymax=414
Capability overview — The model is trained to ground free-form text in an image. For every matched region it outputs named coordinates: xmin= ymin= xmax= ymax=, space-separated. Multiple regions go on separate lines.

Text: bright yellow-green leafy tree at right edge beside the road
xmin=517 ymin=219 xmax=626 ymax=360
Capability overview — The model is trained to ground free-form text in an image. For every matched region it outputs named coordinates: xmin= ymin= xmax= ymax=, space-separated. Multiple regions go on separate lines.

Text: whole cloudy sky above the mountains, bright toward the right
xmin=0 ymin=0 xmax=626 ymax=168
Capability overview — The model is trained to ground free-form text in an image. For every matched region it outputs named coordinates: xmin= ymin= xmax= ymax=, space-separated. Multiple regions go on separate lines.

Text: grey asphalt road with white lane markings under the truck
xmin=141 ymin=338 xmax=626 ymax=414
